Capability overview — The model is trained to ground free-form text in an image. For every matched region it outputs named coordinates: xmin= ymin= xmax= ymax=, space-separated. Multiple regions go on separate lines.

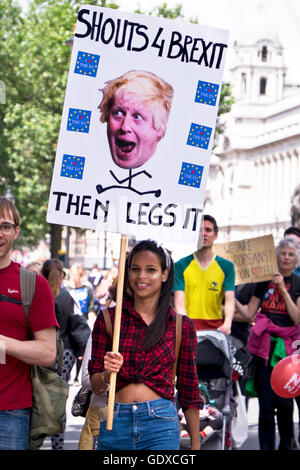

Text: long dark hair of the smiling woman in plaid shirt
xmin=123 ymin=240 xmax=174 ymax=351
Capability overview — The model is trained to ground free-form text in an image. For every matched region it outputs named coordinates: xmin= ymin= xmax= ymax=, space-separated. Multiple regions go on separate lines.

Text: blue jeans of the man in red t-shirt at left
xmin=0 ymin=408 xmax=31 ymax=450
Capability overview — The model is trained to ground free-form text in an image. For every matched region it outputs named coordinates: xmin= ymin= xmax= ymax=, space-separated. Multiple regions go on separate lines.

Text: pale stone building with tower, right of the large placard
xmin=205 ymin=20 xmax=300 ymax=242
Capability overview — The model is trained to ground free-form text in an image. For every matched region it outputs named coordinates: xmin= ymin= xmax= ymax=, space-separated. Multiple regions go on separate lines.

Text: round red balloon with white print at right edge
xmin=271 ymin=354 xmax=300 ymax=398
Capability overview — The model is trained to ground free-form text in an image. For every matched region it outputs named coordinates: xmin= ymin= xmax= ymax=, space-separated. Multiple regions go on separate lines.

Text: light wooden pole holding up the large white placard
xmin=106 ymin=235 xmax=127 ymax=431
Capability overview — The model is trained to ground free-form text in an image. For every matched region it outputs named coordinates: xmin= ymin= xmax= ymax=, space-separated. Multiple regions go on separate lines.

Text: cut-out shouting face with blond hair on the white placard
xmin=99 ymin=72 xmax=173 ymax=169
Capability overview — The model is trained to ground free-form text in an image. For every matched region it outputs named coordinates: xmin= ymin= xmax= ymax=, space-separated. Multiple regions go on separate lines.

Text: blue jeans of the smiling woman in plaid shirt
xmin=97 ymin=398 xmax=180 ymax=450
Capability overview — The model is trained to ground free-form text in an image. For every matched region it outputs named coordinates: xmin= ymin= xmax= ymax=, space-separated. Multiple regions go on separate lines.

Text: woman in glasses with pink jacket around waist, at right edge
xmin=236 ymin=238 xmax=300 ymax=450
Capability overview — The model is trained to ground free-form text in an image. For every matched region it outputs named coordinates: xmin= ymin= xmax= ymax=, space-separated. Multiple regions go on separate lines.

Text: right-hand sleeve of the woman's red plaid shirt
xmin=177 ymin=315 xmax=203 ymax=409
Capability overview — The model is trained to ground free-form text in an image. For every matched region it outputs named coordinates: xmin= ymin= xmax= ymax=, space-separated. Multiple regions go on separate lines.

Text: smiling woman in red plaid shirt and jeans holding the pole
xmin=89 ymin=240 xmax=203 ymax=450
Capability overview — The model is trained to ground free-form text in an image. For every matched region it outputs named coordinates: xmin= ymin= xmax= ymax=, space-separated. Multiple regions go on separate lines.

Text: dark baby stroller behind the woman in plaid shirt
xmin=181 ymin=330 xmax=235 ymax=450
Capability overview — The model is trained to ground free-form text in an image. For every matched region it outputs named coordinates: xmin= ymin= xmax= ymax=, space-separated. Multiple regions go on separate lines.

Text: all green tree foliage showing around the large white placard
xmin=0 ymin=0 xmax=232 ymax=255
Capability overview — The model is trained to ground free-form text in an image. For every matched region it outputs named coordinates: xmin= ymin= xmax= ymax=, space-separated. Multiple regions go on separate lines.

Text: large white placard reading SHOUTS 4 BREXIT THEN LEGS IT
xmin=47 ymin=5 xmax=228 ymax=242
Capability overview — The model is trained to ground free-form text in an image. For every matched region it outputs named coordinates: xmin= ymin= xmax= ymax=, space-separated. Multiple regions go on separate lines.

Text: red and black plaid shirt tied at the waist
xmin=88 ymin=302 xmax=203 ymax=408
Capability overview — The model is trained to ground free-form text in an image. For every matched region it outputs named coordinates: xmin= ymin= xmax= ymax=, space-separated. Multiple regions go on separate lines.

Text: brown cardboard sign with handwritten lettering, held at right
xmin=214 ymin=235 xmax=278 ymax=285
